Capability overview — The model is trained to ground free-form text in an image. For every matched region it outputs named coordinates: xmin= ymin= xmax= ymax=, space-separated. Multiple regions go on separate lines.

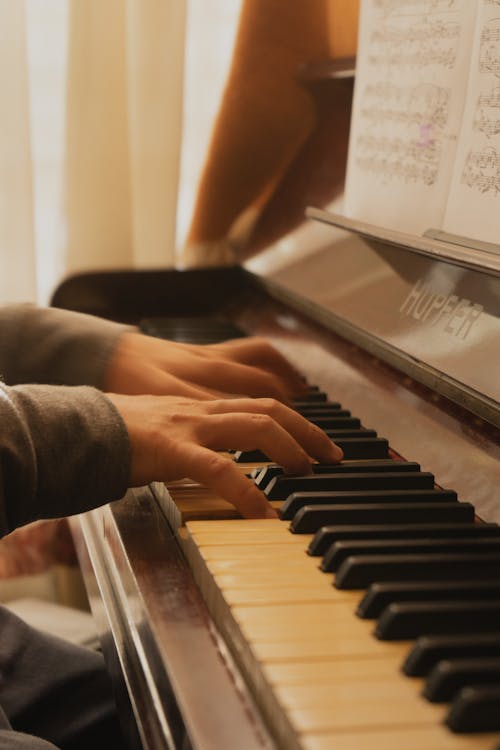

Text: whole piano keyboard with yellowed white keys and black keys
xmin=162 ymin=392 xmax=500 ymax=750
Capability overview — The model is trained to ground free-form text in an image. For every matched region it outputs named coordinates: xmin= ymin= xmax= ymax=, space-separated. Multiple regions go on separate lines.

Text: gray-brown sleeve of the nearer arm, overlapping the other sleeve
xmin=0 ymin=384 xmax=130 ymax=535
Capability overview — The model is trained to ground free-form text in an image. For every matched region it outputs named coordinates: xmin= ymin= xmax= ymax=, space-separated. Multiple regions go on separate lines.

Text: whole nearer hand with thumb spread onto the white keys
xmin=108 ymin=394 xmax=342 ymax=518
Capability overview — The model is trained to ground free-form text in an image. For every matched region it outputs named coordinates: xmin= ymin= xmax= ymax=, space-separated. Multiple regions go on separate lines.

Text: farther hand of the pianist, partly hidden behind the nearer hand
xmin=104 ymin=333 xmax=305 ymax=402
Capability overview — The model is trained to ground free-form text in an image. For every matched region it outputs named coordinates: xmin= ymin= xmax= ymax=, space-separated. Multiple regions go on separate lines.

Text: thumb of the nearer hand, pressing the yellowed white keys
xmin=172 ymin=444 xmax=277 ymax=518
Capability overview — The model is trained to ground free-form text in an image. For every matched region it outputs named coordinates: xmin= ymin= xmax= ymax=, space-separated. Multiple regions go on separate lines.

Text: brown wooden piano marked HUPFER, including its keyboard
xmin=52 ymin=60 xmax=500 ymax=750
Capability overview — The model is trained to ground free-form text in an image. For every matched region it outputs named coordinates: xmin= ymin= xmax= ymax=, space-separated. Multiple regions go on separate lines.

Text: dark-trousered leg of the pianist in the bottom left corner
xmin=0 ymin=608 xmax=125 ymax=750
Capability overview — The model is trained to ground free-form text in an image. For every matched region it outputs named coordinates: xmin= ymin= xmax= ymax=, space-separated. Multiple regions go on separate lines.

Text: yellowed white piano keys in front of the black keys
xmin=185 ymin=520 xmax=495 ymax=750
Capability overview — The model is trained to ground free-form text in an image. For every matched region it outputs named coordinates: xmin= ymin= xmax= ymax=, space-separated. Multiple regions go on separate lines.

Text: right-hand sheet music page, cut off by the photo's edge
xmin=443 ymin=0 xmax=500 ymax=253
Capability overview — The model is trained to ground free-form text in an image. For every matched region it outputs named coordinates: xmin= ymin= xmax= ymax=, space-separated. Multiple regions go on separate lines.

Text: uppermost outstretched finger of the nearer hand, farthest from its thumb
xmin=201 ymin=398 xmax=343 ymax=463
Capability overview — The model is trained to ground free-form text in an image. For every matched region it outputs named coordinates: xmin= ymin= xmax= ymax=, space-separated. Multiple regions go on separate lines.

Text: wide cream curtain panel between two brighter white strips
xmin=66 ymin=0 xmax=185 ymax=271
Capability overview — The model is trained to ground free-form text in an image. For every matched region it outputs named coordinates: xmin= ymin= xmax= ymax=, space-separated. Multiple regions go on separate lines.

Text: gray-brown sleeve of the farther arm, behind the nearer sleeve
xmin=0 ymin=305 xmax=131 ymax=387
